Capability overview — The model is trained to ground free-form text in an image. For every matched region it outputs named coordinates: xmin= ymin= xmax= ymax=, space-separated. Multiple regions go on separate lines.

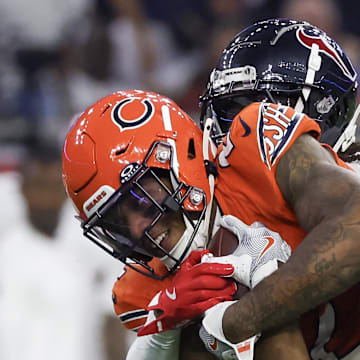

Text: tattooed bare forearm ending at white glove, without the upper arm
xmin=223 ymin=217 xmax=360 ymax=343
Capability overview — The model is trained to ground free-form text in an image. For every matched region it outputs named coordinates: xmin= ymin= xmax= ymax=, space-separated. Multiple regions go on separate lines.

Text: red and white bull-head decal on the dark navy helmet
xmin=296 ymin=27 xmax=356 ymax=80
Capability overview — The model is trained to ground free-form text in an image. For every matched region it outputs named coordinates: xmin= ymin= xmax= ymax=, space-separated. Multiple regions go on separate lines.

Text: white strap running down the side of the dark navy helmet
xmin=295 ymin=43 xmax=321 ymax=112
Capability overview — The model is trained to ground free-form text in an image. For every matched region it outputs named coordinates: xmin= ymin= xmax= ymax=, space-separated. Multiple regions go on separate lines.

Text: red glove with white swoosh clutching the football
xmin=138 ymin=250 xmax=236 ymax=336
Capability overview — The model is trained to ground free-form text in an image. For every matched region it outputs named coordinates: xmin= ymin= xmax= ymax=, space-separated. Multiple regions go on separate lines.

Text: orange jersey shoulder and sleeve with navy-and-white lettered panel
xmin=215 ymin=103 xmax=320 ymax=250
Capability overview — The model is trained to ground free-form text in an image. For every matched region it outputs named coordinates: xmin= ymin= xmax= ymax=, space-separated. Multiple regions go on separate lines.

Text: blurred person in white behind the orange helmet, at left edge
xmin=0 ymin=147 xmax=133 ymax=360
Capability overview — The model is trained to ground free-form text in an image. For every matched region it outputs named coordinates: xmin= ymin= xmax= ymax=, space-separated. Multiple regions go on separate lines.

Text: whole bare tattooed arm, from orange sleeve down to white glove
xmin=223 ymin=135 xmax=360 ymax=342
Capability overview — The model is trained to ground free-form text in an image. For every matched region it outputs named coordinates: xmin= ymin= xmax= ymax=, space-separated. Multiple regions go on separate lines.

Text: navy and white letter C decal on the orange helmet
xmin=111 ymin=97 xmax=155 ymax=131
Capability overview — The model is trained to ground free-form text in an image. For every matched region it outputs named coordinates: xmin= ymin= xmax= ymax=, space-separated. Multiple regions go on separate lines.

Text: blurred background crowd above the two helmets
xmin=0 ymin=0 xmax=360 ymax=166
